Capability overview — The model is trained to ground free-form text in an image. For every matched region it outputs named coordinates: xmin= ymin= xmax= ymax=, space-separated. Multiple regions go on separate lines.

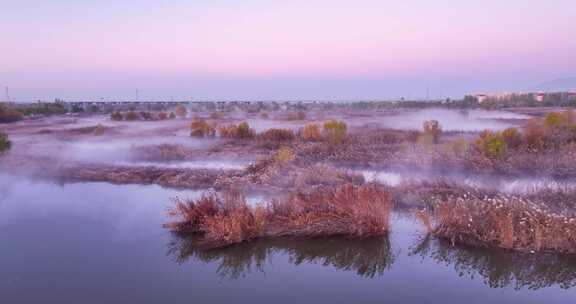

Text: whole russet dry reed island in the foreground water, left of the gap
xmin=166 ymin=184 xmax=392 ymax=247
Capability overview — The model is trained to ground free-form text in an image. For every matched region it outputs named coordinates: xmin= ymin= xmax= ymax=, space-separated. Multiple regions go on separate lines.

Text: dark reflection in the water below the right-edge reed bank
xmin=411 ymin=238 xmax=576 ymax=290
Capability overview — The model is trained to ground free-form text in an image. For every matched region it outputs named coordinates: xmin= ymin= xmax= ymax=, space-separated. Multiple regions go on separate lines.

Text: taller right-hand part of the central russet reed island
xmin=270 ymin=184 xmax=393 ymax=237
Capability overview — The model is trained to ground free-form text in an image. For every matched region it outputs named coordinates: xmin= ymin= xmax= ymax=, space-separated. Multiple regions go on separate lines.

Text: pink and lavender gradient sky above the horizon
xmin=0 ymin=0 xmax=576 ymax=100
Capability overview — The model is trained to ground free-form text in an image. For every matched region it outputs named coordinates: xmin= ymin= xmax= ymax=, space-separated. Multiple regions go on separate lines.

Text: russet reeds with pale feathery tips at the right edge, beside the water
xmin=418 ymin=194 xmax=576 ymax=254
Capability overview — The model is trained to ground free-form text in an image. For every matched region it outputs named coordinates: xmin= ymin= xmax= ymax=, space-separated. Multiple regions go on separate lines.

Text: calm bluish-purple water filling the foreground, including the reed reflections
xmin=0 ymin=175 xmax=576 ymax=303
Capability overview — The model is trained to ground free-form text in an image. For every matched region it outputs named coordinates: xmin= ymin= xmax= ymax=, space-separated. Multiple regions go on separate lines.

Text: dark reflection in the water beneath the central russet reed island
xmin=168 ymin=235 xmax=395 ymax=279
